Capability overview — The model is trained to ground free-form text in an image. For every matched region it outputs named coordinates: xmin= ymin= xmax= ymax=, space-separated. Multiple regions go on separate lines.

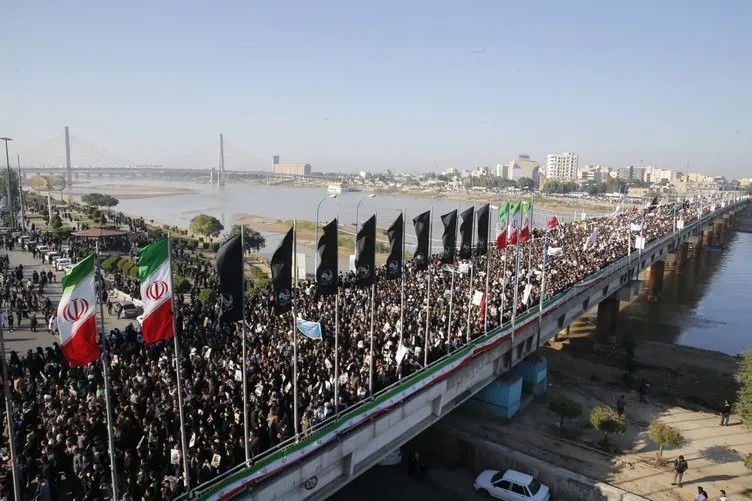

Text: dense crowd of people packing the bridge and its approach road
xmin=0 ymin=195 xmax=736 ymax=500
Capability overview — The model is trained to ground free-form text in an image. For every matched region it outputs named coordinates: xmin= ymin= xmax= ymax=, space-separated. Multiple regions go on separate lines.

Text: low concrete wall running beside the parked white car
xmin=416 ymin=423 xmax=649 ymax=501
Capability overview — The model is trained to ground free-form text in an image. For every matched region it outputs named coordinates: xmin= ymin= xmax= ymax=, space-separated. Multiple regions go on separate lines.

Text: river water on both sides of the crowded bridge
xmin=77 ymin=180 xmax=752 ymax=354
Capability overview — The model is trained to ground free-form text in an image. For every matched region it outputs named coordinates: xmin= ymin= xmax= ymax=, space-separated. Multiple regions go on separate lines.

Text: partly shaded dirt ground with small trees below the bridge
xmin=447 ymin=340 xmax=752 ymax=501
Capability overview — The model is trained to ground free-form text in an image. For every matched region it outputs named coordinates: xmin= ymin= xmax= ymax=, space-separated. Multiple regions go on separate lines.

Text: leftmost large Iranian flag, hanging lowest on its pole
xmin=57 ymin=254 xmax=100 ymax=367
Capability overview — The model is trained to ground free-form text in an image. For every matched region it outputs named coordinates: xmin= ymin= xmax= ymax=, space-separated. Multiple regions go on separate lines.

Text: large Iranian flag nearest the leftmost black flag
xmin=138 ymin=238 xmax=175 ymax=344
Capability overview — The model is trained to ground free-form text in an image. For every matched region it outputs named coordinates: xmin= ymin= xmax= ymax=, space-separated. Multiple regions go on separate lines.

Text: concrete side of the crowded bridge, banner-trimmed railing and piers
xmin=178 ymin=199 xmax=748 ymax=501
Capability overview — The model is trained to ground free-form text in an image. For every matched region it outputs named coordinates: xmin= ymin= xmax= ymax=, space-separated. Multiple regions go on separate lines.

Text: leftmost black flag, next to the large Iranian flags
xmin=217 ymin=230 xmax=243 ymax=322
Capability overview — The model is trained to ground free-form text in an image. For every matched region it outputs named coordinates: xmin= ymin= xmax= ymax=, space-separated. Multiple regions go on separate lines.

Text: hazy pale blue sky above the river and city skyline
xmin=0 ymin=0 xmax=752 ymax=177
